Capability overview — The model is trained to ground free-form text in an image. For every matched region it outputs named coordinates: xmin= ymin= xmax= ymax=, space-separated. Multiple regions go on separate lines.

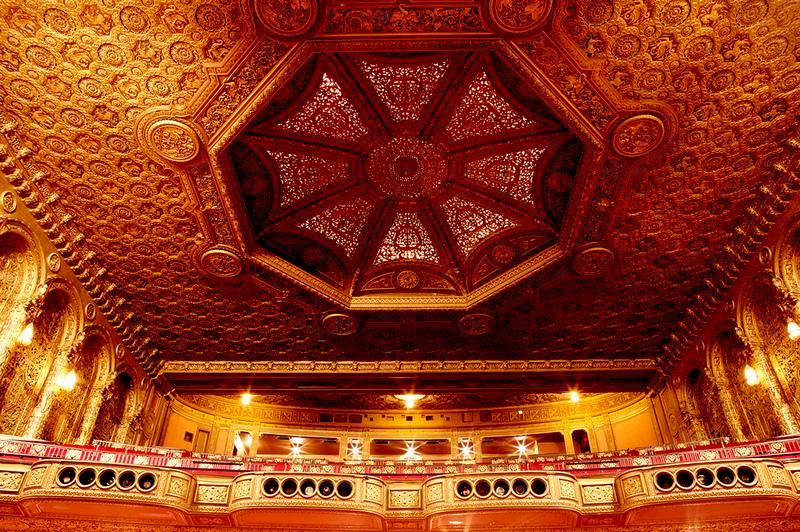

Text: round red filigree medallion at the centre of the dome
xmin=367 ymin=136 xmax=447 ymax=200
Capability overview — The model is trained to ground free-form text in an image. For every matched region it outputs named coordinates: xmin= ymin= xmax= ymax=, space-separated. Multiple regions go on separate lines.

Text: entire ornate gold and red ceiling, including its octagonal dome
xmin=0 ymin=0 xmax=800 ymax=408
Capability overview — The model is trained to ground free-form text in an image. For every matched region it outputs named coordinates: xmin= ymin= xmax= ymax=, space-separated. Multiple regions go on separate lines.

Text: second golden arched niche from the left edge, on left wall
xmin=0 ymin=289 xmax=77 ymax=434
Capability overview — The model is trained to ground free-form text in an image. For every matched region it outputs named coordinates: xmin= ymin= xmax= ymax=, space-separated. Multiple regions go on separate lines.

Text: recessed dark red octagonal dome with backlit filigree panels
xmin=228 ymin=51 xmax=584 ymax=308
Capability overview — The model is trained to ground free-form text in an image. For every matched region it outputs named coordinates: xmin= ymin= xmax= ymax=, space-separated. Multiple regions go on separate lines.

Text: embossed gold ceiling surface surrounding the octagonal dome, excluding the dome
xmin=0 ymin=0 xmax=800 ymax=402
